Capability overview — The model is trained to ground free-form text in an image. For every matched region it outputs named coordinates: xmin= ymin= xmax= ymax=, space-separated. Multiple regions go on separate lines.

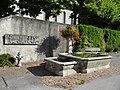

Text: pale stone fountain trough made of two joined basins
xmin=45 ymin=53 xmax=112 ymax=76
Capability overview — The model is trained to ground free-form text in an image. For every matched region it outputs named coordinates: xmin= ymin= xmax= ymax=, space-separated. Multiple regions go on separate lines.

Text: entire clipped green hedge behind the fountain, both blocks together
xmin=74 ymin=25 xmax=120 ymax=52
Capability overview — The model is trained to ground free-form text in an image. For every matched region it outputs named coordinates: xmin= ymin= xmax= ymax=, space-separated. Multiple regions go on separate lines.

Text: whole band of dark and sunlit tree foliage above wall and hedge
xmin=17 ymin=0 xmax=120 ymax=29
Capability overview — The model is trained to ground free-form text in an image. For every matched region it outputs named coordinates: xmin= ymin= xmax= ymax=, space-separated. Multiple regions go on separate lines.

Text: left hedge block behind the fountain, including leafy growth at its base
xmin=76 ymin=25 xmax=105 ymax=51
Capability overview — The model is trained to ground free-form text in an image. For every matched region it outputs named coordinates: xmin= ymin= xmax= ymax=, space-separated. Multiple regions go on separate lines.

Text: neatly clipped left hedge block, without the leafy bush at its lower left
xmin=79 ymin=25 xmax=105 ymax=51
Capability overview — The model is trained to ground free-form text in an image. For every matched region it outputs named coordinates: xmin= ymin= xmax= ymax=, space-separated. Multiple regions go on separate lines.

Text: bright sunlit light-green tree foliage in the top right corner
xmin=86 ymin=0 xmax=120 ymax=22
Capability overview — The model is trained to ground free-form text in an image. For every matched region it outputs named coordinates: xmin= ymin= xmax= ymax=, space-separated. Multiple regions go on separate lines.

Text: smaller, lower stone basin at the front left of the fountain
xmin=45 ymin=57 xmax=77 ymax=76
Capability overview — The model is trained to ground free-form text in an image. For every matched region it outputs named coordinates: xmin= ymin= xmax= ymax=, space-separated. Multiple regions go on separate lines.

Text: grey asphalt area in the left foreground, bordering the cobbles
xmin=0 ymin=73 xmax=62 ymax=90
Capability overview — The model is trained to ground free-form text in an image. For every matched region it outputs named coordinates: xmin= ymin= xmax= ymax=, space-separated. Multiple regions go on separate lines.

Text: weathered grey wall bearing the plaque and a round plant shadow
xmin=0 ymin=16 xmax=66 ymax=63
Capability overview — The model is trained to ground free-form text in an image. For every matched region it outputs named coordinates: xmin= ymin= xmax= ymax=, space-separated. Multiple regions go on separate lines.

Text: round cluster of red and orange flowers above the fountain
xmin=61 ymin=26 xmax=80 ymax=41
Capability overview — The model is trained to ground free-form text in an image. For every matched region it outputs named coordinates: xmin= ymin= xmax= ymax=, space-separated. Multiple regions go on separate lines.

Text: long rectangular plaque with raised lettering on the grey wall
xmin=4 ymin=34 xmax=40 ymax=45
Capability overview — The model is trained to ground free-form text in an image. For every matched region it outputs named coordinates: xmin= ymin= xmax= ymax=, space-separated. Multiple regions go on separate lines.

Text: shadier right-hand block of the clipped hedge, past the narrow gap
xmin=104 ymin=29 xmax=120 ymax=52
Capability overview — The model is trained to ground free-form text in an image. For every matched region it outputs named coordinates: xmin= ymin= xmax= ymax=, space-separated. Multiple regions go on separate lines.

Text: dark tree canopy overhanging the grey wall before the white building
xmin=18 ymin=0 xmax=62 ymax=20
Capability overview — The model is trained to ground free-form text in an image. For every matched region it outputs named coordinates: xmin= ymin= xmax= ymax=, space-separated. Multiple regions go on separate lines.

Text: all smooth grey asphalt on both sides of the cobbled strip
xmin=0 ymin=54 xmax=120 ymax=90
